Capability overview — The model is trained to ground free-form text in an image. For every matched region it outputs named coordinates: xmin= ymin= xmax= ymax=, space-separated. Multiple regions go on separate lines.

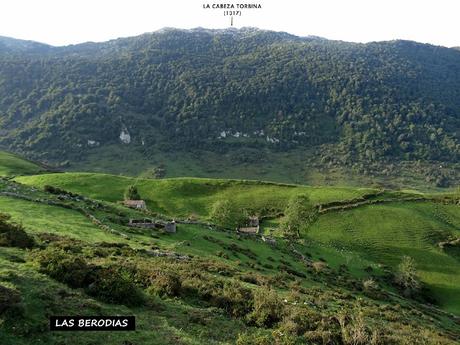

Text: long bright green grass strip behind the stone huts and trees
xmin=17 ymin=173 xmax=374 ymax=216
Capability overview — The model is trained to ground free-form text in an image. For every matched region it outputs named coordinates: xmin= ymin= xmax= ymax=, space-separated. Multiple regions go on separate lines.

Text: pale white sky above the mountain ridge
xmin=0 ymin=0 xmax=460 ymax=47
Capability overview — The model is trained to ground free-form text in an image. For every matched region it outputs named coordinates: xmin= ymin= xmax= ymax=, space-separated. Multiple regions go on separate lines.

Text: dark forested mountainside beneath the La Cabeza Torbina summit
xmin=0 ymin=28 xmax=460 ymax=186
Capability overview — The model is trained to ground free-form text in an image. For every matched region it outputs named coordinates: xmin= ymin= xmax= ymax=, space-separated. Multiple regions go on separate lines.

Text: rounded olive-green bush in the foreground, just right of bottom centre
xmin=248 ymin=288 xmax=284 ymax=327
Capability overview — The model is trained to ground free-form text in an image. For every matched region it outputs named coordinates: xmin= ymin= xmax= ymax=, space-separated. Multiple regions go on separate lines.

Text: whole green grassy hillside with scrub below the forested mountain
xmin=0 ymin=155 xmax=460 ymax=345
